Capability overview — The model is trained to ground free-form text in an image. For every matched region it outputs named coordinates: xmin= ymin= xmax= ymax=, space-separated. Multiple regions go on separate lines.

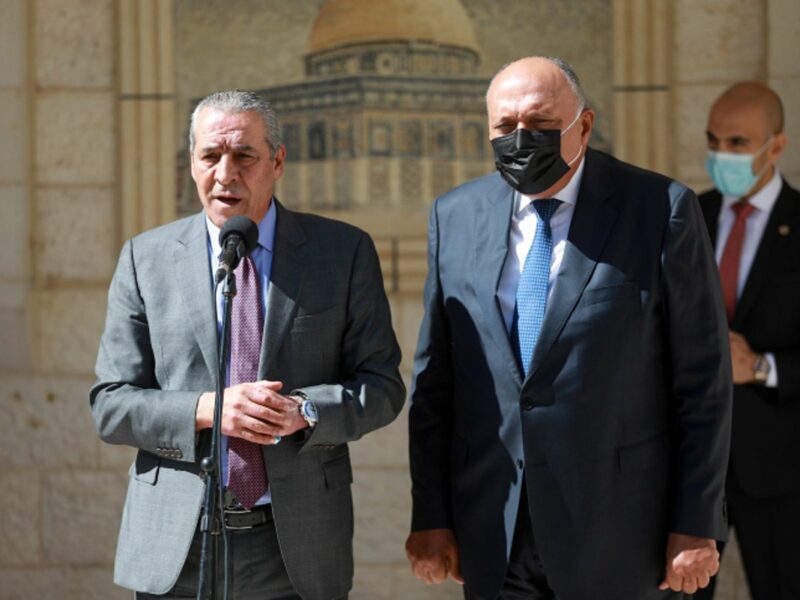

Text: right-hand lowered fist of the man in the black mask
xmin=658 ymin=533 xmax=719 ymax=594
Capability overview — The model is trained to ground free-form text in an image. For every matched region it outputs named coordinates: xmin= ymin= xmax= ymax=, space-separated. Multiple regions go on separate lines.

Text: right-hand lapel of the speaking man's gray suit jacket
xmin=258 ymin=200 xmax=306 ymax=378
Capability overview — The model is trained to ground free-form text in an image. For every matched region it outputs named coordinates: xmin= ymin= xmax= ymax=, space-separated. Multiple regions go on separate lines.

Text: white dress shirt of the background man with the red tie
xmin=716 ymin=169 xmax=783 ymax=387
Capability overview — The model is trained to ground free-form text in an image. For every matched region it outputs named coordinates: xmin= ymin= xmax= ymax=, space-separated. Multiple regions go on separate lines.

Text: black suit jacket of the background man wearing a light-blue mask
xmin=700 ymin=181 xmax=800 ymax=498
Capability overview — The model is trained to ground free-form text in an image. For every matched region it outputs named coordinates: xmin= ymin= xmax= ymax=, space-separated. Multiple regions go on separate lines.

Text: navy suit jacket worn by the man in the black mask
xmin=409 ymin=150 xmax=731 ymax=600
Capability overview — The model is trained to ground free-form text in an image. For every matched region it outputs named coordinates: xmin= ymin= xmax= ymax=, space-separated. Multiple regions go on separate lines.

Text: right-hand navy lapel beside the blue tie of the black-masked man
xmin=526 ymin=151 xmax=617 ymax=381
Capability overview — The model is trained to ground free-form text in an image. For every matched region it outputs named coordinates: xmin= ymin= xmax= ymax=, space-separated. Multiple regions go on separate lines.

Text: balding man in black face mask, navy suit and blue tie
xmin=406 ymin=57 xmax=731 ymax=600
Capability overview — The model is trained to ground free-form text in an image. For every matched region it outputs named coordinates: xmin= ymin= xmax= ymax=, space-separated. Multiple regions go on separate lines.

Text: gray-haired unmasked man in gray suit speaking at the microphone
xmin=90 ymin=91 xmax=405 ymax=600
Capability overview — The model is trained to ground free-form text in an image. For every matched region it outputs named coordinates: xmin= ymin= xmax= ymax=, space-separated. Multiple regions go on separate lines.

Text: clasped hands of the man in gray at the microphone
xmin=195 ymin=381 xmax=308 ymax=445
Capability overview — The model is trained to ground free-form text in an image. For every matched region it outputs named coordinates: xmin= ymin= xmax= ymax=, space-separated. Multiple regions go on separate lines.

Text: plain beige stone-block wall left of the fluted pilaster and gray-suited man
xmin=0 ymin=0 xmax=128 ymax=600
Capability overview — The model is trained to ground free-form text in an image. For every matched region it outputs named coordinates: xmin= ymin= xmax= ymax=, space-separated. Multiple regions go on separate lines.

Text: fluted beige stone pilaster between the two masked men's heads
xmin=612 ymin=0 xmax=674 ymax=173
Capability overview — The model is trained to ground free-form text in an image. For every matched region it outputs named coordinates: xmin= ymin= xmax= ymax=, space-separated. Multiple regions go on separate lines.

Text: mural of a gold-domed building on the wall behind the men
xmin=178 ymin=0 xmax=611 ymax=292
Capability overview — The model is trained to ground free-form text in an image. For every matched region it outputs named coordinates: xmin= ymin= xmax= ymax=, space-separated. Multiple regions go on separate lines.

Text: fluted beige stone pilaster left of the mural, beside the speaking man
xmin=118 ymin=0 xmax=177 ymax=239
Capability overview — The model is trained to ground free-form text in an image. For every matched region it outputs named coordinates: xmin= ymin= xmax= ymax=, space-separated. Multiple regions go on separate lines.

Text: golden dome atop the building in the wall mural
xmin=306 ymin=0 xmax=478 ymax=54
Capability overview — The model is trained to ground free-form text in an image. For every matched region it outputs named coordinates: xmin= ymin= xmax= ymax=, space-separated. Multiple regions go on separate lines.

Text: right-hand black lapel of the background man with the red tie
xmin=731 ymin=181 xmax=796 ymax=331
